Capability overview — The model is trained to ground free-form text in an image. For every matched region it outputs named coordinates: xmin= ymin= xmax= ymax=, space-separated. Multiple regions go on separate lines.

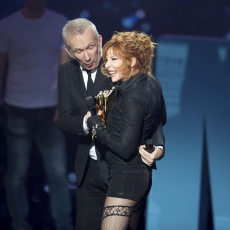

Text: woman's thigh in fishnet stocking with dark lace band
xmin=101 ymin=197 xmax=137 ymax=230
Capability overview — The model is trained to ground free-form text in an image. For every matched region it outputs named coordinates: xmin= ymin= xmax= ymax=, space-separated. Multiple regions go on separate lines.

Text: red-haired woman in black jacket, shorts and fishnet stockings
xmin=87 ymin=31 xmax=162 ymax=230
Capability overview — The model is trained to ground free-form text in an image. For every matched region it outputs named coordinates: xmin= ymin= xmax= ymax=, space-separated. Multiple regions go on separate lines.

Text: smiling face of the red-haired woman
xmin=105 ymin=47 xmax=128 ymax=82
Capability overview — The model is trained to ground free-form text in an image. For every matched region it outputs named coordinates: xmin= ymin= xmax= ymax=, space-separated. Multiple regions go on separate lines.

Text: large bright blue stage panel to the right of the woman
xmin=146 ymin=36 xmax=230 ymax=230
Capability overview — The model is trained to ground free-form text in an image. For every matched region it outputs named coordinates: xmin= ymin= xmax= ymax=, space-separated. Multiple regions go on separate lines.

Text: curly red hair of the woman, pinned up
xmin=101 ymin=31 xmax=157 ymax=78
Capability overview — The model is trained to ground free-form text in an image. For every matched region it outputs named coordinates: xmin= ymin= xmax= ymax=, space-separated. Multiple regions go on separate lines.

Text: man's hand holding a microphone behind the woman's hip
xmin=138 ymin=145 xmax=164 ymax=166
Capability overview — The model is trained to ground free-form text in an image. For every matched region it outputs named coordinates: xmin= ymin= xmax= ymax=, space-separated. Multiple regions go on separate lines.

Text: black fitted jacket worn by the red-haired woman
xmin=94 ymin=74 xmax=166 ymax=164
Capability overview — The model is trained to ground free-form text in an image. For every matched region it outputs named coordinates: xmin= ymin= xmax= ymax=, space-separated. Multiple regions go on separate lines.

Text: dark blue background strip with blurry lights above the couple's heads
xmin=0 ymin=0 xmax=230 ymax=41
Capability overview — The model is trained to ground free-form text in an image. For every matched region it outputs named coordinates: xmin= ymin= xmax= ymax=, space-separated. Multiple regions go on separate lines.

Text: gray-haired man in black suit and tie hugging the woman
xmin=58 ymin=18 xmax=164 ymax=230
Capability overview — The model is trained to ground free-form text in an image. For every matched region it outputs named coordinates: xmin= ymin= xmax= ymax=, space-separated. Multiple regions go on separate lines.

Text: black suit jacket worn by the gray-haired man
xmin=58 ymin=60 xmax=164 ymax=185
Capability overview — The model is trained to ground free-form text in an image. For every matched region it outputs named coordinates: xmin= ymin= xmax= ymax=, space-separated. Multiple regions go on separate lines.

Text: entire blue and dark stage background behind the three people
xmin=0 ymin=0 xmax=230 ymax=230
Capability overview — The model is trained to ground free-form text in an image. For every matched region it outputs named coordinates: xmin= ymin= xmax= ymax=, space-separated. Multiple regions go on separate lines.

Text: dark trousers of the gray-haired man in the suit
xmin=76 ymin=159 xmax=107 ymax=230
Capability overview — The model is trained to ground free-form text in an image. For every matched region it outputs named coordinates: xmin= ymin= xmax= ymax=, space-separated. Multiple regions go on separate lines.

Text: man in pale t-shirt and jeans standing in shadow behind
xmin=0 ymin=0 xmax=72 ymax=230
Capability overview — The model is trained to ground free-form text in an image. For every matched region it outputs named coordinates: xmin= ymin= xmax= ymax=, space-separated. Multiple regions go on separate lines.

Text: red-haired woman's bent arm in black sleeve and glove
xmin=87 ymin=95 xmax=148 ymax=160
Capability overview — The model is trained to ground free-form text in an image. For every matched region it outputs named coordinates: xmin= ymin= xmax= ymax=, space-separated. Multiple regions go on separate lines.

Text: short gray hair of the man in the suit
xmin=62 ymin=18 xmax=99 ymax=49
